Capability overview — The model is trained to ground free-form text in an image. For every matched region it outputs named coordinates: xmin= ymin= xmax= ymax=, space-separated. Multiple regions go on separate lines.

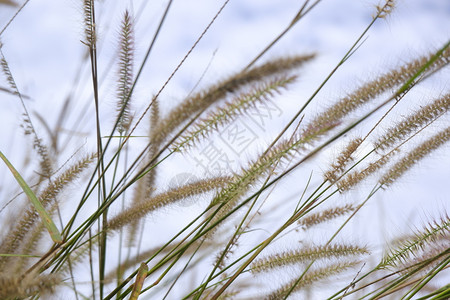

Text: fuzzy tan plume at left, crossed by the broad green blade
xmin=0 ymin=154 xmax=96 ymax=266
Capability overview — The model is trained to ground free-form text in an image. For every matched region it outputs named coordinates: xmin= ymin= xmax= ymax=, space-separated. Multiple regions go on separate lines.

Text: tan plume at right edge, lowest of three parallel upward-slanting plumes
xmin=379 ymin=127 xmax=450 ymax=186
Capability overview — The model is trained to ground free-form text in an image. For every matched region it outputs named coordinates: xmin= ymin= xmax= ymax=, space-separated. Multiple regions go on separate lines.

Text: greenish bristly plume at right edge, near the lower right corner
xmin=377 ymin=216 xmax=450 ymax=269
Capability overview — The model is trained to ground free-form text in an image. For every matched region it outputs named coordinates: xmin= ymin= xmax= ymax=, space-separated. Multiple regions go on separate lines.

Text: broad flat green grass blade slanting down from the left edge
xmin=0 ymin=151 xmax=62 ymax=243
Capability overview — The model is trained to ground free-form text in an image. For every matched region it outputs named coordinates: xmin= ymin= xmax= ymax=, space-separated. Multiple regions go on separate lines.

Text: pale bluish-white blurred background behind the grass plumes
xmin=0 ymin=0 xmax=450 ymax=298
